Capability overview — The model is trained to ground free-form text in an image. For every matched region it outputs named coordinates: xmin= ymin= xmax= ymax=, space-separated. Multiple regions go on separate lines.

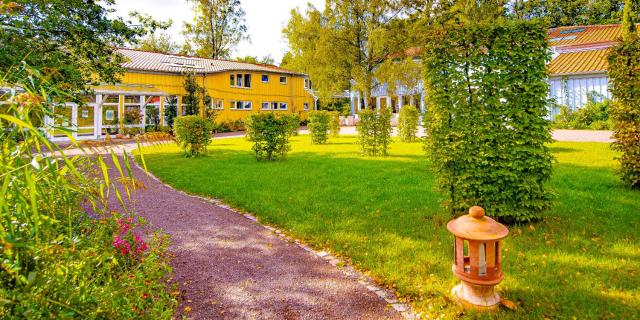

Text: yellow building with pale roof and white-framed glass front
xmin=48 ymin=49 xmax=316 ymax=140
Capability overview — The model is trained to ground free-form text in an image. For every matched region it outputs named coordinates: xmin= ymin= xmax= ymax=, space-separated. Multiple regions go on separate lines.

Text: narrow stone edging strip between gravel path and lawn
xmin=134 ymin=158 xmax=421 ymax=320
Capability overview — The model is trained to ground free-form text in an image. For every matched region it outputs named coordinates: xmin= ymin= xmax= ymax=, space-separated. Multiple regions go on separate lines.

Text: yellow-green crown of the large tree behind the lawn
xmin=282 ymin=0 xmax=431 ymax=100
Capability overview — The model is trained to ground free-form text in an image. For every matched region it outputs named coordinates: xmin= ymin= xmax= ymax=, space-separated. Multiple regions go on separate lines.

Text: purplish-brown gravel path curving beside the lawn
xmin=104 ymin=158 xmax=401 ymax=319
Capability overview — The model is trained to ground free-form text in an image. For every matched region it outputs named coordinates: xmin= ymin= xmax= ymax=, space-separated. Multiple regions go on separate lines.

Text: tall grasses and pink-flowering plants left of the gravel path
xmin=0 ymin=69 xmax=177 ymax=319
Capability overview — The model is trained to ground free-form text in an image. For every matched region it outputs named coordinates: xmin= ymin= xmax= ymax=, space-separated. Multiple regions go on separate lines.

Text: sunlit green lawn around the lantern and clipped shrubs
xmin=140 ymin=136 xmax=640 ymax=319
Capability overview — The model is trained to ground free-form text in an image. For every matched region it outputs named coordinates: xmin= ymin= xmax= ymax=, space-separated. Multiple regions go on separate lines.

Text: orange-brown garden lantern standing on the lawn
xmin=447 ymin=206 xmax=509 ymax=311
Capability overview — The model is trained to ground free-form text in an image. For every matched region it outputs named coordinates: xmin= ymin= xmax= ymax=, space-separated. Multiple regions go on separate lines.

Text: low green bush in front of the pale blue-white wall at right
xmin=553 ymin=99 xmax=613 ymax=130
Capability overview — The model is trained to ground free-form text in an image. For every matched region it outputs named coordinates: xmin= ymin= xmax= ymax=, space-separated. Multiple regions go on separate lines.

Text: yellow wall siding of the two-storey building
xmin=122 ymin=71 xmax=314 ymax=122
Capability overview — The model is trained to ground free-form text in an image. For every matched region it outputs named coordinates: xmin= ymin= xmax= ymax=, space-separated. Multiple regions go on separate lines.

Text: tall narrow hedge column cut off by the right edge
xmin=609 ymin=4 xmax=640 ymax=188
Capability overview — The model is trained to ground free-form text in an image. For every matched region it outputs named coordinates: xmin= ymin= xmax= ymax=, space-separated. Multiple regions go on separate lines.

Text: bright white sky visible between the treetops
xmin=109 ymin=0 xmax=325 ymax=63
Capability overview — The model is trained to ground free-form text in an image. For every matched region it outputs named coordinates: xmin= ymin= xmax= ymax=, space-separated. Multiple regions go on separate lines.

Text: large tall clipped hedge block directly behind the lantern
xmin=424 ymin=20 xmax=552 ymax=222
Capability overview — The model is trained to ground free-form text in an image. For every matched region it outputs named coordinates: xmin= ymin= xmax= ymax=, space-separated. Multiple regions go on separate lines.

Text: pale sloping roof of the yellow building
xmin=117 ymin=48 xmax=304 ymax=76
